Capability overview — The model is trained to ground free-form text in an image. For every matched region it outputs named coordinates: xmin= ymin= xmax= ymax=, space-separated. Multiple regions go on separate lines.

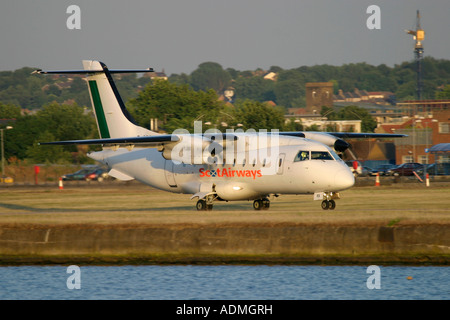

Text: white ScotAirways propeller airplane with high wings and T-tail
xmin=35 ymin=60 xmax=405 ymax=210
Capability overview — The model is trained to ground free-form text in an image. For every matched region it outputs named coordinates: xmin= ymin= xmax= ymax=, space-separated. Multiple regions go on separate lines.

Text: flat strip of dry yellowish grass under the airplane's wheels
xmin=0 ymin=183 xmax=450 ymax=225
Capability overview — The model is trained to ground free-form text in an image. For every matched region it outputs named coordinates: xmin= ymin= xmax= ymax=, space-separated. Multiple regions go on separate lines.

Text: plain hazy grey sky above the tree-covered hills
xmin=0 ymin=0 xmax=450 ymax=75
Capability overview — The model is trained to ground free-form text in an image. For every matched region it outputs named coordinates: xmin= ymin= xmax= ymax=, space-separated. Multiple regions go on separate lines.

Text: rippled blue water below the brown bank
xmin=0 ymin=266 xmax=450 ymax=300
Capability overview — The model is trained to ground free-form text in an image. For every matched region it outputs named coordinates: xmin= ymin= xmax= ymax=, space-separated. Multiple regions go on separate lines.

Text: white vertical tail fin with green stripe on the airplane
xmin=83 ymin=60 xmax=156 ymax=139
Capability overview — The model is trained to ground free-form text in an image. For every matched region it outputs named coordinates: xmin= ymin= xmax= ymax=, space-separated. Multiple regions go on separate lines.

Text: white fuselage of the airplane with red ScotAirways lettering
xmin=89 ymin=137 xmax=354 ymax=200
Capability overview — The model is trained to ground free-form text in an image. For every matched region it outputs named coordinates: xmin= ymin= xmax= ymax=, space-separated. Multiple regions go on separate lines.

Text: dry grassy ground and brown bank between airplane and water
xmin=0 ymin=177 xmax=450 ymax=265
